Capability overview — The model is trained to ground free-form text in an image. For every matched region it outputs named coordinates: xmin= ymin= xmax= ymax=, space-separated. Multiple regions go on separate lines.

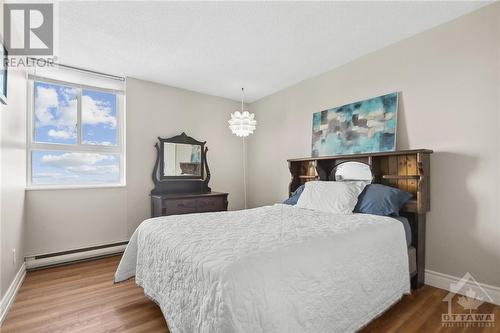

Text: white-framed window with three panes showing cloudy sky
xmin=28 ymin=77 xmax=124 ymax=188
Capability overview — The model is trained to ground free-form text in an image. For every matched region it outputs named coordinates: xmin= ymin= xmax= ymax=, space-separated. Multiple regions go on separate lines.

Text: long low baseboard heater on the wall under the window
xmin=25 ymin=245 xmax=127 ymax=270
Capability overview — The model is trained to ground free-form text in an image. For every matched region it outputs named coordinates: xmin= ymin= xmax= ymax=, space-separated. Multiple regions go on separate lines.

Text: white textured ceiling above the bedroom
xmin=57 ymin=1 xmax=486 ymax=102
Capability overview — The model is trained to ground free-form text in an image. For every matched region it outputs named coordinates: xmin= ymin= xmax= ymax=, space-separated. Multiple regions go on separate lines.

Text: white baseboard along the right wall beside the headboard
xmin=425 ymin=269 xmax=500 ymax=305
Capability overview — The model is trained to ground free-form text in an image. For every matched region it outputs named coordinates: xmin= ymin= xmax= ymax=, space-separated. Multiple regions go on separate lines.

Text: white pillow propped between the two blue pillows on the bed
xmin=297 ymin=181 xmax=366 ymax=214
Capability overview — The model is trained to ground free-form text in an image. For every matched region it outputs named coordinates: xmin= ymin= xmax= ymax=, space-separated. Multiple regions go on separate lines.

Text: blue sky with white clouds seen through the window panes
xmin=32 ymin=81 xmax=120 ymax=185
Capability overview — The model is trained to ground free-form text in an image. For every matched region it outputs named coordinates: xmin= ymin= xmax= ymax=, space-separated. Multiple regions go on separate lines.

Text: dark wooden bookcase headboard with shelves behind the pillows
xmin=288 ymin=149 xmax=432 ymax=288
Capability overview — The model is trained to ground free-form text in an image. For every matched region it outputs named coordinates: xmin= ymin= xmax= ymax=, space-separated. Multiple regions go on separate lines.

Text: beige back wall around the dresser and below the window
xmin=26 ymin=78 xmax=243 ymax=256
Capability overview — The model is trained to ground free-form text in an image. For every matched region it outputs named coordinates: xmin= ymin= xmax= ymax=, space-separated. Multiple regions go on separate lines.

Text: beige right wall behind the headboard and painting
xmin=247 ymin=3 xmax=500 ymax=286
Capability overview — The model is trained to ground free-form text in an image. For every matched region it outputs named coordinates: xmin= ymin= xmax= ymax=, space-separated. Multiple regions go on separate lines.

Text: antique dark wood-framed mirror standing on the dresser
xmin=151 ymin=133 xmax=210 ymax=194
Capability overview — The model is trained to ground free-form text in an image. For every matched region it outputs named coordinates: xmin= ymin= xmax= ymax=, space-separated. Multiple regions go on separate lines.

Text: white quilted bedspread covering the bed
xmin=115 ymin=205 xmax=410 ymax=333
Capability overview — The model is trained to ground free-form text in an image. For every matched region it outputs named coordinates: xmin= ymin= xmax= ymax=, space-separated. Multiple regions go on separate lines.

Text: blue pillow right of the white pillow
xmin=354 ymin=184 xmax=412 ymax=216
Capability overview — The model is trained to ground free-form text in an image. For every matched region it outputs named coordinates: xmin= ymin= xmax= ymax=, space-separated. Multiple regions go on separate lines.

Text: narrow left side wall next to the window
xmin=0 ymin=6 xmax=26 ymax=296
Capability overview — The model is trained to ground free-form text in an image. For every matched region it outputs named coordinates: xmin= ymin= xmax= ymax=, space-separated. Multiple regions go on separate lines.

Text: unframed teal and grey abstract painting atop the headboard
xmin=312 ymin=93 xmax=398 ymax=157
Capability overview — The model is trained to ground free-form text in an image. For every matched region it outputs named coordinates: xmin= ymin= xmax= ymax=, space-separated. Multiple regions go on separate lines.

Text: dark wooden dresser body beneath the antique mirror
xmin=151 ymin=192 xmax=228 ymax=217
